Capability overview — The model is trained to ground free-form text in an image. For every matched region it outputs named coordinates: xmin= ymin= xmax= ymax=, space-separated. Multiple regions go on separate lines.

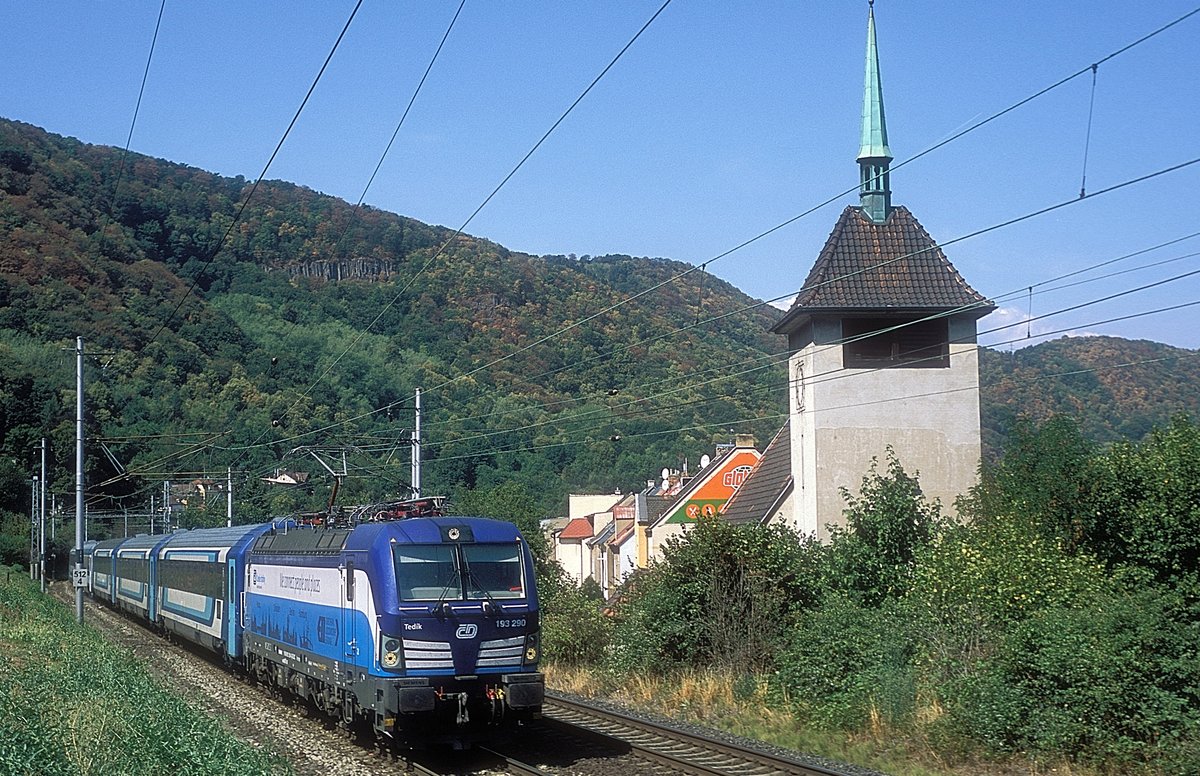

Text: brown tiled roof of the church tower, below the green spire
xmin=772 ymin=205 xmax=995 ymax=332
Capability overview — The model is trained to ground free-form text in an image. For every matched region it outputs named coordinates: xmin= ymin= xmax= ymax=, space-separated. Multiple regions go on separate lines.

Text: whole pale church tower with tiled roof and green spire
xmin=772 ymin=6 xmax=995 ymax=540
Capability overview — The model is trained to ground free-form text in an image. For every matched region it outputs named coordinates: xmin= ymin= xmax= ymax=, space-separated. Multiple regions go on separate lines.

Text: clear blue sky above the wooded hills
xmin=7 ymin=0 xmax=1200 ymax=348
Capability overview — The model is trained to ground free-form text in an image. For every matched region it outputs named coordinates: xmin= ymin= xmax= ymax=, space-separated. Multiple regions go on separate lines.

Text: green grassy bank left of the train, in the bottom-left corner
xmin=0 ymin=569 xmax=290 ymax=776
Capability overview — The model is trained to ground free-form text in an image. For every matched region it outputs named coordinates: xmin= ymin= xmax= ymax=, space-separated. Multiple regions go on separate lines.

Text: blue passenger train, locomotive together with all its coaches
xmin=84 ymin=501 xmax=545 ymax=747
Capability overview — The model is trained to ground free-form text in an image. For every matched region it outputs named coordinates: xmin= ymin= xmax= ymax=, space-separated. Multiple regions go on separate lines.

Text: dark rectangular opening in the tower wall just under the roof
xmin=841 ymin=318 xmax=950 ymax=369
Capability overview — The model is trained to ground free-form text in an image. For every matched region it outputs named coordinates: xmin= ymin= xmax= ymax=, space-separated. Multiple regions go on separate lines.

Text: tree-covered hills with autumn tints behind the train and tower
xmin=0 ymin=120 xmax=1200 ymax=527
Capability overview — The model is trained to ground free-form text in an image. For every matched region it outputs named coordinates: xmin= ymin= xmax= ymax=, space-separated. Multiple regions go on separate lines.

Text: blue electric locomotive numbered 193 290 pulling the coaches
xmin=245 ymin=517 xmax=544 ymax=745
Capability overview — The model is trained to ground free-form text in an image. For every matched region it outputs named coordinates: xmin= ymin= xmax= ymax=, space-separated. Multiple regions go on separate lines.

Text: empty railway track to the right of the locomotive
xmin=542 ymin=692 xmax=865 ymax=776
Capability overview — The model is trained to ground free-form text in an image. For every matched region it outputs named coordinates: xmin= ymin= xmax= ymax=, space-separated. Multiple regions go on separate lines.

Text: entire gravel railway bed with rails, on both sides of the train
xmin=53 ymin=590 xmax=872 ymax=776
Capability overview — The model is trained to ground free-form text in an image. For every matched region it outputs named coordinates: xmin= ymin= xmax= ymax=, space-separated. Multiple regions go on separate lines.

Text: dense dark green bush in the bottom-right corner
xmin=946 ymin=589 xmax=1200 ymax=774
